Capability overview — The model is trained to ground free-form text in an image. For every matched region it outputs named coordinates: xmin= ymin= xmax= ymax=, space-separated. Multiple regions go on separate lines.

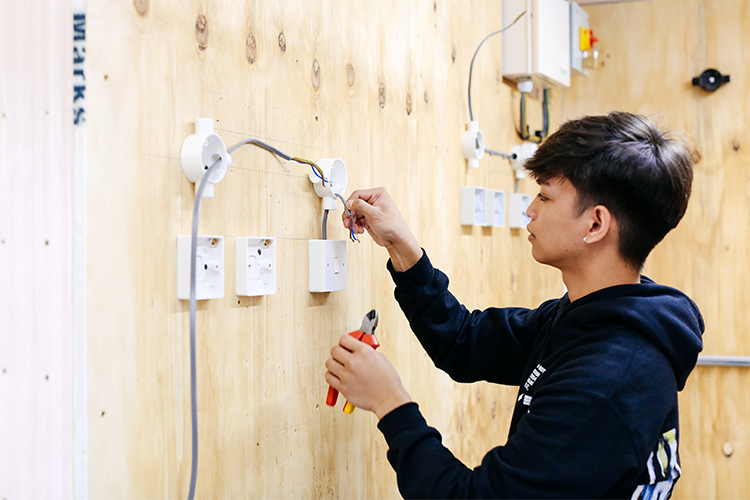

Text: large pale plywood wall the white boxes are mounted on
xmin=86 ymin=0 xmax=562 ymax=498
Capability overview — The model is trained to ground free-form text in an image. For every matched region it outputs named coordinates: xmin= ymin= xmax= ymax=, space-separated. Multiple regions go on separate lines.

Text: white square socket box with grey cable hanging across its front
xmin=177 ymin=235 xmax=224 ymax=300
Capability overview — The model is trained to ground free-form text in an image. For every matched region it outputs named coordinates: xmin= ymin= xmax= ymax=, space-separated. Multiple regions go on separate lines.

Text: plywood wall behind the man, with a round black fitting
xmin=561 ymin=0 xmax=750 ymax=499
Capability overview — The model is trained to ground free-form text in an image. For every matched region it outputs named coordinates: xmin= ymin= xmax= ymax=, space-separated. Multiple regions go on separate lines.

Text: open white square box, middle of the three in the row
xmin=235 ymin=237 xmax=276 ymax=297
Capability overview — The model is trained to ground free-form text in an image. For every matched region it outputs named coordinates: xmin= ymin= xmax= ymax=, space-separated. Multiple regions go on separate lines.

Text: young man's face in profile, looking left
xmin=526 ymin=176 xmax=588 ymax=271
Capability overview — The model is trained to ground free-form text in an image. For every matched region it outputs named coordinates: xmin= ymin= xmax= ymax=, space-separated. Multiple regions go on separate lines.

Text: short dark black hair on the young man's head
xmin=526 ymin=112 xmax=693 ymax=269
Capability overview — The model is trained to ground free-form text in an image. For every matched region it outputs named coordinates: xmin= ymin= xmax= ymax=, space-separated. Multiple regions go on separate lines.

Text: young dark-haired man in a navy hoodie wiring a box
xmin=326 ymin=113 xmax=703 ymax=499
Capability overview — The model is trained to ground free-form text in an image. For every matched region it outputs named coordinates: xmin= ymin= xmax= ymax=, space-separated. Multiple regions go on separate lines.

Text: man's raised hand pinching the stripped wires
xmin=342 ymin=188 xmax=422 ymax=271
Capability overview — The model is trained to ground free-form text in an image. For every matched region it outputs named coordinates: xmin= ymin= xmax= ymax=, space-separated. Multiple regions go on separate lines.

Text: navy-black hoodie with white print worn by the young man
xmin=378 ymin=254 xmax=704 ymax=499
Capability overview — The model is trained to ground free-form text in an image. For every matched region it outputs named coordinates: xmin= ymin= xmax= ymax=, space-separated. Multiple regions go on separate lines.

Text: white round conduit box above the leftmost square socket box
xmin=180 ymin=118 xmax=232 ymax=198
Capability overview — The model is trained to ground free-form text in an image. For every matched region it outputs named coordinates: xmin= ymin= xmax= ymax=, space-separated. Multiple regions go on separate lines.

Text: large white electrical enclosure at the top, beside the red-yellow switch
xmin=503 ymin=0 xmax=570 ymax=88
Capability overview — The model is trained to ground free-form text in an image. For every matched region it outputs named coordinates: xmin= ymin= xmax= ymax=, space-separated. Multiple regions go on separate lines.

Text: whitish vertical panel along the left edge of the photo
xmin=0 ymin=1 xmax=74 ymax=498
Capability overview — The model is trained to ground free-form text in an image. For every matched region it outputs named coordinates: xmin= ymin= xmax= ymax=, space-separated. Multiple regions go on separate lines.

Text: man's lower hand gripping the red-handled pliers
xmin=326 ymin=335 xmax=411 ymax=419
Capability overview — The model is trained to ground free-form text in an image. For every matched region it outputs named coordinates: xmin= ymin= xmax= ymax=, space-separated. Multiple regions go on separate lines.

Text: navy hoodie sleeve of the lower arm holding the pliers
xmin=378 ymin=394 xmax=645 ymax=498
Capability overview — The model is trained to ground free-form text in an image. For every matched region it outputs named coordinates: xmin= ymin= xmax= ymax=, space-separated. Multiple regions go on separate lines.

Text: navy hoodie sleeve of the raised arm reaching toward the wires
xmin=394 ymin=253 xmax=558 ymax=385
